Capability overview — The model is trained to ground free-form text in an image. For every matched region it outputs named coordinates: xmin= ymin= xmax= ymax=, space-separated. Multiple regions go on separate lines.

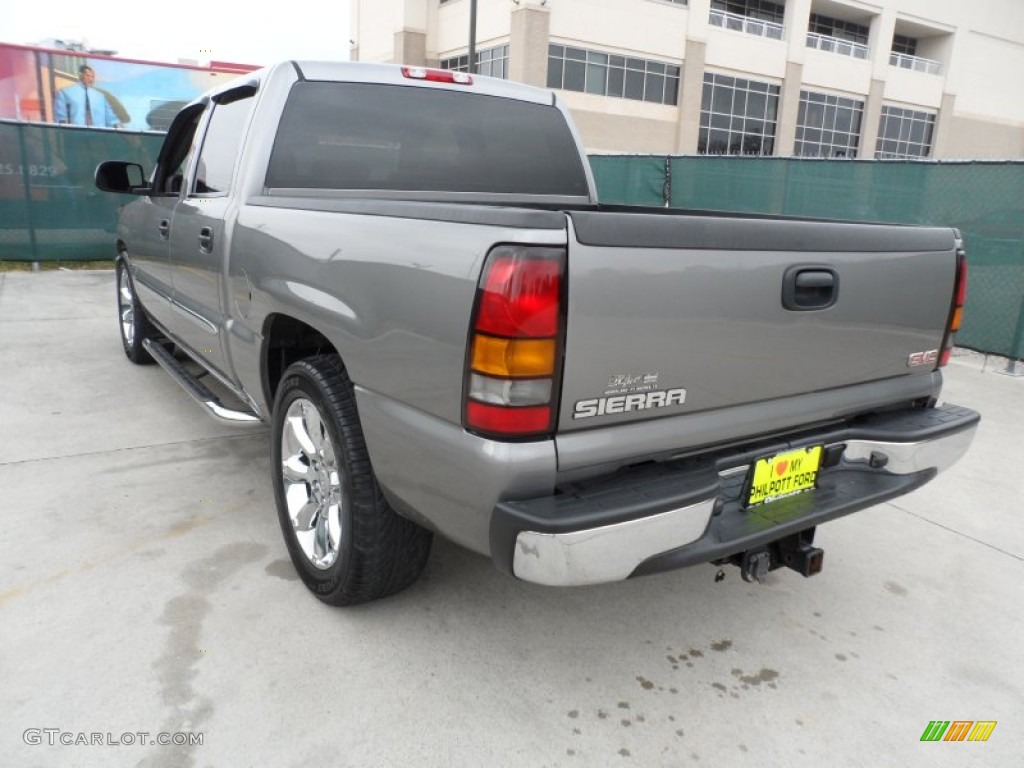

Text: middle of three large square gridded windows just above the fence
xmin=793 ymin=91 xmax=864 ymax=158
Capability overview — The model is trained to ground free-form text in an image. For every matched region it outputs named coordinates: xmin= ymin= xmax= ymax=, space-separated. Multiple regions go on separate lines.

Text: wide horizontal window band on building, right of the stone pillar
xmin=548 ymin=45 xmax=680 ymax=104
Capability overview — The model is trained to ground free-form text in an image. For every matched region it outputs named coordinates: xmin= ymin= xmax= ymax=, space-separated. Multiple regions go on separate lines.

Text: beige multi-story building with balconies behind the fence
xmin=351 ymin=0 xmax=1024 ymax=158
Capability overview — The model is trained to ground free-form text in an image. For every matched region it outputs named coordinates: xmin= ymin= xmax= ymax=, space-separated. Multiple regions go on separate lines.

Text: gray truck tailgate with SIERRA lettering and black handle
xmin=558 ymin=210 xmax=956 ymax=434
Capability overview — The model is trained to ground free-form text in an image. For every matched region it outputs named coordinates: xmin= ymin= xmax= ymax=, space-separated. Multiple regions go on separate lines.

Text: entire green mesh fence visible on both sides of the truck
xmin=0 ymin=121 xmax=1024 ymax=359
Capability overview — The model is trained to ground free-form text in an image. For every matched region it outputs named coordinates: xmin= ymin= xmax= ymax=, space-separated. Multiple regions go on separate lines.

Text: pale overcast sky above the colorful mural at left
xmin=0 ymin=0 xmax=350 ymax=66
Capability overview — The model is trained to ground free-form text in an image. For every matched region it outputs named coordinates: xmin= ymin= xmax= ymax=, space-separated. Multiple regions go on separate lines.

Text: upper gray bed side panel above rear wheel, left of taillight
xmin=228 ymin=201 xmax=566 ymax=423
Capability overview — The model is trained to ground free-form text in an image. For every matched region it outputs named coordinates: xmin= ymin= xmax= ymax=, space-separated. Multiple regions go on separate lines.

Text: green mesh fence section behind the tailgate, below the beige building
xmin=591 ymin=156 xmax=1024 ymax=359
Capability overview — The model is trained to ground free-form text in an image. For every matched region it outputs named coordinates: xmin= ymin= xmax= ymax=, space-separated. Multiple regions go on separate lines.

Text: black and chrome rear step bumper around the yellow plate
xmin=492 ymin=406 xmax=980 ymax=586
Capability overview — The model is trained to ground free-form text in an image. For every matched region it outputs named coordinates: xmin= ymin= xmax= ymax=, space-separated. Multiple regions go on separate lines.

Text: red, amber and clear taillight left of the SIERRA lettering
xmin=464 ymin=246 xmax=565 ymax=439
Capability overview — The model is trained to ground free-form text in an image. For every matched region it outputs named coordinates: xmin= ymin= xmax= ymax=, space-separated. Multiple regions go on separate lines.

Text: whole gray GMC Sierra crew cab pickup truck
xmin=96 ymin=61 xmax=979 ymax=605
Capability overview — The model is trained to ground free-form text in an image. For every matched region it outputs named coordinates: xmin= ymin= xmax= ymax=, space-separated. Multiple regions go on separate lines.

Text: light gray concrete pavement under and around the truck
xmin=0 ymin=271 xmax=1024 ymax=768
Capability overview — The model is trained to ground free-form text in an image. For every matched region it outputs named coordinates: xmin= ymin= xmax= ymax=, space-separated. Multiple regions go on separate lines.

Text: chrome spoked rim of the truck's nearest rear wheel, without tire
xmin=281 ymin=397 xmax=342 ymax=570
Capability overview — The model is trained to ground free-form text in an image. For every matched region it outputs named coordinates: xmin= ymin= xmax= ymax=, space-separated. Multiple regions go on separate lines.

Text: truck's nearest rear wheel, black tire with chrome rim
xmin=270 ymin=355 xmax=432 ymax=605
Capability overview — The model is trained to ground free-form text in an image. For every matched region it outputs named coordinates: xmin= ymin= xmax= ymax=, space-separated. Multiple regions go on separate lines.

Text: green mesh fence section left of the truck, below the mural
xmin=0 ymin=121 xmax=163 ymax=261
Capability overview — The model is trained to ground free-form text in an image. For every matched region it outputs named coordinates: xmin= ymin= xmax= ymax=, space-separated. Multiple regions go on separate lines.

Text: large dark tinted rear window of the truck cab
xmin=266 ymin=82 xmax=588 ymax=197
